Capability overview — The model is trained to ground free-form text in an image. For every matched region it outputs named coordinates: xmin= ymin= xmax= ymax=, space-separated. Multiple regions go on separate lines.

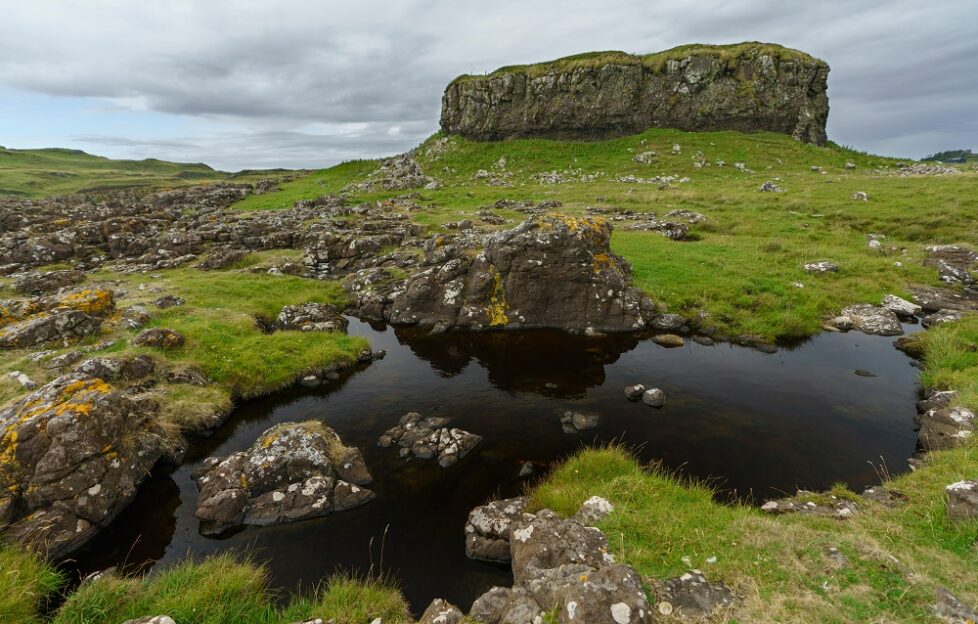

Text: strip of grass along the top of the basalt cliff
xmin=452 ymin=41 xmax=822 ymax=84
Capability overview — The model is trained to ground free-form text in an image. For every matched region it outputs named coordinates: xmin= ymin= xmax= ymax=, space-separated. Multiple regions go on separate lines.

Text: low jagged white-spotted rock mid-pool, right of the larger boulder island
xmin=377 ymin=412 xmax=482 ymax=468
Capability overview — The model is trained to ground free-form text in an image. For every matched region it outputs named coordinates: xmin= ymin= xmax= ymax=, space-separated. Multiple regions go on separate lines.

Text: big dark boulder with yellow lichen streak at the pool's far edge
xmin=382 ymin=214 xmax=654 ymax=332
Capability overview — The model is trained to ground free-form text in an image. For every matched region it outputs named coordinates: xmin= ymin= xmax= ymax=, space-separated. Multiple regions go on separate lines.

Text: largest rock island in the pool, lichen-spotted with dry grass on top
xmin=195 ymin=421 xmax=374 ymax=535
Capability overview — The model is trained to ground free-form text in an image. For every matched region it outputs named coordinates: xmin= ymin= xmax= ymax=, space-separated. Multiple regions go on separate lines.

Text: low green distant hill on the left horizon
xmin=0 ymin=147 xmax=229 ymax=197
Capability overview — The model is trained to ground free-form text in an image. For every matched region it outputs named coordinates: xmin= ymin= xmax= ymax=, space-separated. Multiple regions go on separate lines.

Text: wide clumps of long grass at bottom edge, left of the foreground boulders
xmin=53 ymin=555 xmax=410 ymax=624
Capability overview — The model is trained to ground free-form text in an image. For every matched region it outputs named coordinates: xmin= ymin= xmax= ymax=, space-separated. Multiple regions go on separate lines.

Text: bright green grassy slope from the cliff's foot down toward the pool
xmin=238 ymin=129 xmax=978 ymax=340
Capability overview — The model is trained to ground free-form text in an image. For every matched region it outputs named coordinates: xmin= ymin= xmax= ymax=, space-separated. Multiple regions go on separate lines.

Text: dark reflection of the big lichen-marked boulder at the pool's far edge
xmin=394 ymin=327 xmax=642 ymax=397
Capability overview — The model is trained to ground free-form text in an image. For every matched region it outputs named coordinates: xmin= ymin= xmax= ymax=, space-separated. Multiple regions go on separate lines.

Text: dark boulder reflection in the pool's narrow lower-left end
xmin=60 ymin=473 xmax=180 ymax=581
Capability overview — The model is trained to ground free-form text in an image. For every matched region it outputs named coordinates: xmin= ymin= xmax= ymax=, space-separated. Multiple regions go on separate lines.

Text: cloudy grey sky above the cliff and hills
xmin=0 ymin=0 xmax=978 ymax=171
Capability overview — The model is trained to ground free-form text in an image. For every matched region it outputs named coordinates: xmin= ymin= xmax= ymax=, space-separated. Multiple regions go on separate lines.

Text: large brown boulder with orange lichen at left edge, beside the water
xmin=0 ymin=374 xmax=164 ymax=558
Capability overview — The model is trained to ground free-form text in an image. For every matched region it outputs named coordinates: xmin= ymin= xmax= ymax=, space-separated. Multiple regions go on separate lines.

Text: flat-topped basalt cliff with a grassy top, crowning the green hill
xmin=441 ymin=43 xmax=829 ymax=145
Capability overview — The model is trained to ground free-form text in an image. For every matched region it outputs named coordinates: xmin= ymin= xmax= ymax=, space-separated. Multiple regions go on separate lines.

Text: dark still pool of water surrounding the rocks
xmin=70 ymin=322 xmax=916 ymax=611
